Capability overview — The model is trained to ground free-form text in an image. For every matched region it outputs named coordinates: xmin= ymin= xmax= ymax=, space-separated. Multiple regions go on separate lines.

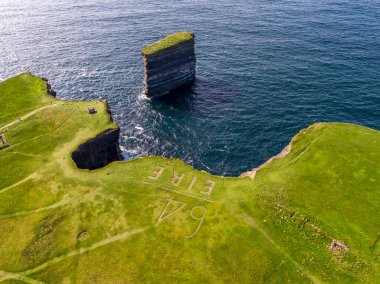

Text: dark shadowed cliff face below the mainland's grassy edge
xmin=72 ymin=128 xmax=121 ymax=170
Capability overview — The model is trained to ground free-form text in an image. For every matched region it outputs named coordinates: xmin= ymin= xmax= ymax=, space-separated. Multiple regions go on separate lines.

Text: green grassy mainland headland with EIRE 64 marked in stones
xmin=0 ymin=73 xmax=380 ymax=283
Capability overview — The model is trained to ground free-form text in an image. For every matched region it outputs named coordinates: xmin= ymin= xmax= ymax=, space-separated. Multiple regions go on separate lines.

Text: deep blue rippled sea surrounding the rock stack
xmin=0 ymin=0 xmax=380 ymax=175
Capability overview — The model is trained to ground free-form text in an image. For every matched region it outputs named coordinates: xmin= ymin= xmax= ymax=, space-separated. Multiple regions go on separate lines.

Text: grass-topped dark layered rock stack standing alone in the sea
xmin=141 ymin=32 xmax=196 ymax=97
